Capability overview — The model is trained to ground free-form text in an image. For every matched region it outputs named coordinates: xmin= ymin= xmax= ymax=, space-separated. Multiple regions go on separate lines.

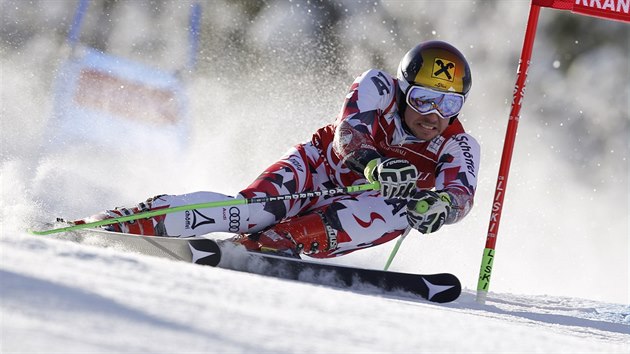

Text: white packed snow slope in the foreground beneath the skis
xmin=0 ymin=232 xmax=630 ymax=353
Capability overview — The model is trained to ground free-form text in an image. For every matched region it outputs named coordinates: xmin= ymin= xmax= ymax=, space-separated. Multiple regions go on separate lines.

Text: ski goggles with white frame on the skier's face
xmin=407 ymin=86 xmax=465 ymax=119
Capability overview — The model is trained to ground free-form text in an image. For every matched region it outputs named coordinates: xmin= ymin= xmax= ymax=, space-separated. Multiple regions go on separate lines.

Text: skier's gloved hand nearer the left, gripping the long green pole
xmin=364 ymin=158 xmax=418 ymax=199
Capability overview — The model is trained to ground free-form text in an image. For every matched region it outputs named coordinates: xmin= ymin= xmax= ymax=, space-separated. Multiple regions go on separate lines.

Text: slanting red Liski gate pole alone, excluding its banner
xmin=477 ymin=4 xmax=540 ymax=304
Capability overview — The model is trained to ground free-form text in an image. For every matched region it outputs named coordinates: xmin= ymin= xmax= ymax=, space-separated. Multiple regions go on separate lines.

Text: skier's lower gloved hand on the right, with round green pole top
xmin=407 ymin=190 xmax=451 ymax=234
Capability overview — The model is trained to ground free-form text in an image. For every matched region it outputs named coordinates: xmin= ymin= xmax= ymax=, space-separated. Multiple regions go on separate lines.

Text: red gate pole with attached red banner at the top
xmin=477 ymin=0 xmax=630 ymax=304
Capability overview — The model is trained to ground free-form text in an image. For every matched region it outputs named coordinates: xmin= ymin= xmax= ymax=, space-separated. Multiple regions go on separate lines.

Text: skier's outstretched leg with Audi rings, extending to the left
xmin=74 ymin=145 xmax=324 ymax=237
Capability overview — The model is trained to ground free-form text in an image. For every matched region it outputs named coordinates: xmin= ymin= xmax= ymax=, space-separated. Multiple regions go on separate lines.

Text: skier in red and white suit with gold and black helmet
xmin=76 ymin=41 xmax=479 ymax=258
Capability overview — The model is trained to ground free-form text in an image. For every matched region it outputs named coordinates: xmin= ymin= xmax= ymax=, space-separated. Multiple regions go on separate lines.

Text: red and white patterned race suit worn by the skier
xmin=90 ymin=70 xmax=480 ymax=257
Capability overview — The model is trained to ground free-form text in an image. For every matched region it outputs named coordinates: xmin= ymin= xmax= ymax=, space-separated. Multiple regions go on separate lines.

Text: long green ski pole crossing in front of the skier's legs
xmin=28 ymin=182 xmax=380 ymax=235
